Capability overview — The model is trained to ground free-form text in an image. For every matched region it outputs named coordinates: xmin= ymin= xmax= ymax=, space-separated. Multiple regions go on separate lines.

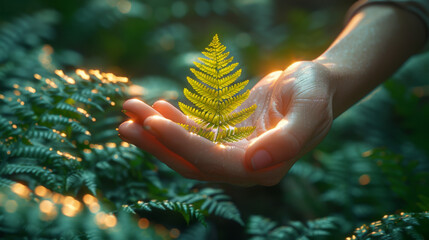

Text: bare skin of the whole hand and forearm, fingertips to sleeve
xmin=119 ymin=4 xmax=425 ymax=186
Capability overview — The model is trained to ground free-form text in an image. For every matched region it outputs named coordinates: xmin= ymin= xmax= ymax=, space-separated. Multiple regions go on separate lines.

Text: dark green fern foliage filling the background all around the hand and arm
xmin=0 ymin=0 xmax=429 ymax=240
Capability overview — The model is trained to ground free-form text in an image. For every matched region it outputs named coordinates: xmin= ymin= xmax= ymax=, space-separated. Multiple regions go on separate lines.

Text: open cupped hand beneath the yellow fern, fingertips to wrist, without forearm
xmin=119 ymin=62 xmax=335 ymax=186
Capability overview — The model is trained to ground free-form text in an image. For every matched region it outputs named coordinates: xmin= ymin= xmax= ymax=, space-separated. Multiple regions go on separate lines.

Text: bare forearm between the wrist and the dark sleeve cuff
xmin=314 ymin=4 xmax=425 ymax=117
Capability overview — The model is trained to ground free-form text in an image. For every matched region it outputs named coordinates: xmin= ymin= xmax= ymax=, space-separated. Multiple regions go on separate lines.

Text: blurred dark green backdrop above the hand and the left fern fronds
xmin=0 ymin=0 xmax=353 ymax=98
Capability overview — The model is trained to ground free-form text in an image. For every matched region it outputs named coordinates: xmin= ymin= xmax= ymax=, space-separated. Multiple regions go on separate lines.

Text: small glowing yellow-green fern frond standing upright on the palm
xmin=179 ymin=34 xmax=256 ymax=143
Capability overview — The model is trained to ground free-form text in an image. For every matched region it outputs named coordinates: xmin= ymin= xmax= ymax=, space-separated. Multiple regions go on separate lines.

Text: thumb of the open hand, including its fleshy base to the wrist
xmin=245 ymin=99 xmax=332 ymax=171
